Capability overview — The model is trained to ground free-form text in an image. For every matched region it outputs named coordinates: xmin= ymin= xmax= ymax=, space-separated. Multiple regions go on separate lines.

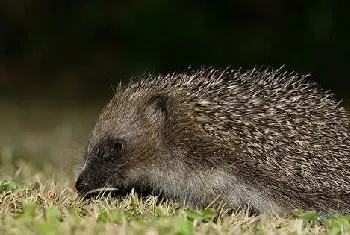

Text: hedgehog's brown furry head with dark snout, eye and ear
xmin=76 ymin=87 xmax=171 ymax=194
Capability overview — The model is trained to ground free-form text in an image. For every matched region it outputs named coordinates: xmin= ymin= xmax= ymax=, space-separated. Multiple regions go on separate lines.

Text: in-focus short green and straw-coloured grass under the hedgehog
xmin=0 ymin=162 xmax=350 ymax=235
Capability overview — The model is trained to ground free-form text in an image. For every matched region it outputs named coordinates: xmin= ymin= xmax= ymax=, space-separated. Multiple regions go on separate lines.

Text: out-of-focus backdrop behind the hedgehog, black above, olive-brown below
xmin=0 ymin=0 xmax=350 ymax=169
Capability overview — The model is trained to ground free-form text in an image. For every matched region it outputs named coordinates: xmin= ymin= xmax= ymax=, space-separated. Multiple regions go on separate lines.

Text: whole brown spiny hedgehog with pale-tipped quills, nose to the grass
xmin=75 ymin=67 xmax=350 ymax=215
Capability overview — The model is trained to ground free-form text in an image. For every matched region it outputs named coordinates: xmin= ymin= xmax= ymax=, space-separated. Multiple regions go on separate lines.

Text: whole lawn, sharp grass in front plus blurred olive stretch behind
xmin=0 ymin=103 xmax=350 ymax=235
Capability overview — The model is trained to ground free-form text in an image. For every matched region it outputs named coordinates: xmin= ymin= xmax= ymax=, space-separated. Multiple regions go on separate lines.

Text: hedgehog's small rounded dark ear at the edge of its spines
xmin=147 ymin=95 xmax=171 ymax=122
